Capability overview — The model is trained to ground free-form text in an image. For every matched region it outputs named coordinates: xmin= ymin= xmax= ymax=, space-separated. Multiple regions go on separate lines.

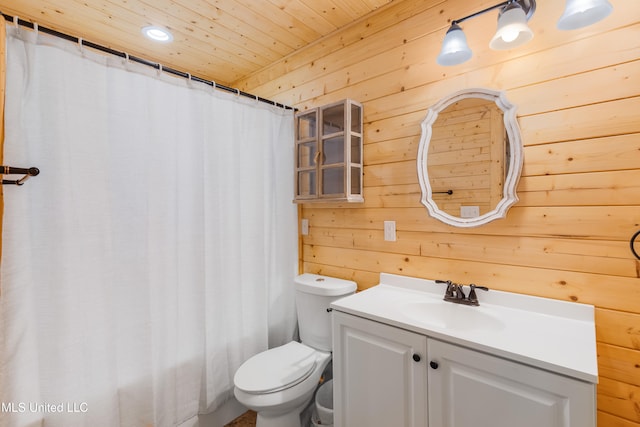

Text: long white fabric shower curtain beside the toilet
xmin=0 ymin=27 xmax=297 ymax=427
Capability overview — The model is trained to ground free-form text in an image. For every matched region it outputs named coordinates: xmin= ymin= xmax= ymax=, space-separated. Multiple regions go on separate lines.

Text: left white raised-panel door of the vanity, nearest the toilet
xmin=333 ymin=310 xmax=428 ymax=427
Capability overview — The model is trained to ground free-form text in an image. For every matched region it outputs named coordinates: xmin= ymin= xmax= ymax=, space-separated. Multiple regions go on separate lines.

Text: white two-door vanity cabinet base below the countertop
xmin=333 ymin=310 xmax=596 ymax=427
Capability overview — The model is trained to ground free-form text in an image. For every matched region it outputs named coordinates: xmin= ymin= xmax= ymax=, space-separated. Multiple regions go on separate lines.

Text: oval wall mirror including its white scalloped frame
xmin=418 ymin=88 xmax=523 ymax=227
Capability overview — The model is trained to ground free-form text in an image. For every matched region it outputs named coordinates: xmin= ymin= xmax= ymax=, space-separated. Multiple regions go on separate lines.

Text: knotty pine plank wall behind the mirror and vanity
xmin=235 ymin=0 xmax=640 ymax=427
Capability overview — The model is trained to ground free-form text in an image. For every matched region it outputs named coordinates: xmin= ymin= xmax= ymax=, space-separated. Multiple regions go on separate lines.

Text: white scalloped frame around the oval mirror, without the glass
xmin=418 ymin=88 xmax=523 ymax=227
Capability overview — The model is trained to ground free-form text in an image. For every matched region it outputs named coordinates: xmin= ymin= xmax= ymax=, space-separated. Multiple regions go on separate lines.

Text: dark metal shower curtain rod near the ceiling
xmin=0 ymin=12 xmax=298 ymax=111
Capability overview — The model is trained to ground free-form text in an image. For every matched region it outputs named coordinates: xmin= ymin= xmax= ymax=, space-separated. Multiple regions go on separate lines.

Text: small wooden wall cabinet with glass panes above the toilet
xmin=294 ymin=99 xmax=364 ymax=203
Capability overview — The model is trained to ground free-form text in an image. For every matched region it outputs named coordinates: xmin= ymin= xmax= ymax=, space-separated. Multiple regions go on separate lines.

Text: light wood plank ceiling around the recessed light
xmin=0 ymin=0 xmax=397 ymax=86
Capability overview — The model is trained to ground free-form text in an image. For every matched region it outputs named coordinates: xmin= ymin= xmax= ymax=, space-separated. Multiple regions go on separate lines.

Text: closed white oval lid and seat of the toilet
xmin=233 ymin=341 xmax=317 ymax=394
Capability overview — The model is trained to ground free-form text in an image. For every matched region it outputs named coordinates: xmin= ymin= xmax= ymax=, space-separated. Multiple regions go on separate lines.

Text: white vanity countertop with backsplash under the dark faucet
xmin=331 ymin=273 xmax=598 ymax=383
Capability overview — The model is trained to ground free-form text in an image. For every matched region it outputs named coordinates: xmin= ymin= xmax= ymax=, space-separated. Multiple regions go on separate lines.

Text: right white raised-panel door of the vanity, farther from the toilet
xmin=428 ymin=339 xmax=596 ymax=427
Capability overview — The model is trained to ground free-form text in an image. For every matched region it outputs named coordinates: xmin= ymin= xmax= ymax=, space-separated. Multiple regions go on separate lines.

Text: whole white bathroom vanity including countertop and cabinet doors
xmin=331 ymin=274 xmax=598 ymax=427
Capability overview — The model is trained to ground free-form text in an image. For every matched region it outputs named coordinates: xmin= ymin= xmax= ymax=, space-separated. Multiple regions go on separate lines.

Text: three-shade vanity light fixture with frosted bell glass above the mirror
xmin=437 ymin=0 xmax=613 ymax=66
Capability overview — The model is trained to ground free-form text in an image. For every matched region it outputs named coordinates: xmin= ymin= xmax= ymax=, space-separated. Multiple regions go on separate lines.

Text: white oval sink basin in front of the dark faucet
xmin=400 ymin=300 xmax=505 ymax=332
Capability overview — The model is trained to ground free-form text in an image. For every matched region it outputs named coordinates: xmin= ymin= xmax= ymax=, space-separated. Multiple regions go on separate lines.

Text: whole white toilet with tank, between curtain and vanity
xmin=233 ymin=273 xmax=356 ymax=427
